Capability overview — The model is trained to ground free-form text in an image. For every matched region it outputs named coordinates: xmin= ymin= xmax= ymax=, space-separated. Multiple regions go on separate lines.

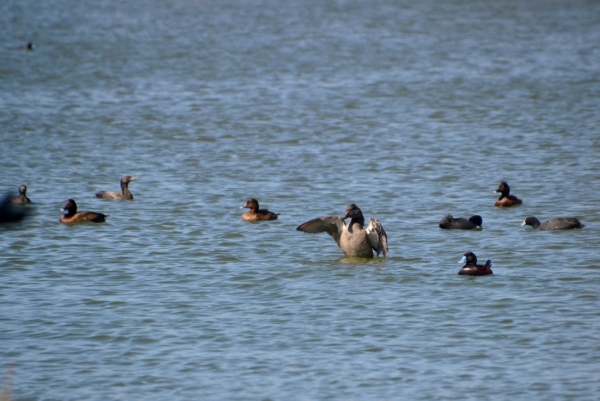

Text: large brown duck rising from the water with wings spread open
xmin=296 ymin=203 xmax=389 ymax=258
